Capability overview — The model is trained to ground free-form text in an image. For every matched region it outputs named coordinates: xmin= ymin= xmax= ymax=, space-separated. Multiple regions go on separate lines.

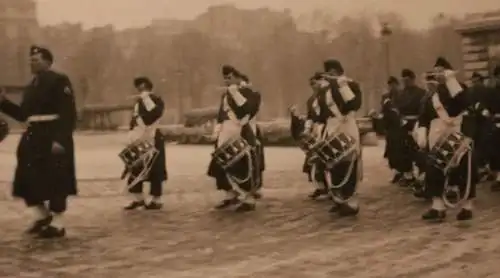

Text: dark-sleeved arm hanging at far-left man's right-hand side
xmin=54 ymin=75 xmax=76 ymax=142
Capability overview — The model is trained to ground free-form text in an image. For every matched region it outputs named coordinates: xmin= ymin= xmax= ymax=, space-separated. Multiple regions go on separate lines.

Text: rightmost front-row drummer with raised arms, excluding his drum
xmin=416 ymin=57 xmax=477 ymax=221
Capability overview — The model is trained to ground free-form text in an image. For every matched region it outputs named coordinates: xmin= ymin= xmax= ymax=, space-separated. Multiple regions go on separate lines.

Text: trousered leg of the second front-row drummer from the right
xmin=330 ymin=159 xmax=359 ymax=216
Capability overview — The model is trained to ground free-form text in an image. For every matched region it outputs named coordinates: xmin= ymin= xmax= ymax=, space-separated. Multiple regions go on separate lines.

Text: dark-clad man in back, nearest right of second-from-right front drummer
xmin=381 ymin=76 xmax=403 ymax=183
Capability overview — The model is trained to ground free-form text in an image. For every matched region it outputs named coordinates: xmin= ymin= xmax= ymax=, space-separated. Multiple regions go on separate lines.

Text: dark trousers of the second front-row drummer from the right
xmin=330 ymin=158 xmax=359 ymax=198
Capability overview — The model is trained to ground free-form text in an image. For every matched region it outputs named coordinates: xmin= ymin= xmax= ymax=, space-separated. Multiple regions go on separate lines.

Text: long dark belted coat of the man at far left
xmin=0 ymin=70 xmax=77 ymax=202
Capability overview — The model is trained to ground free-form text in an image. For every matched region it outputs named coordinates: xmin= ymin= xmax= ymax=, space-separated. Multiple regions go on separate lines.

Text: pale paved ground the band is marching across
xmin=0 ymin=135 xmax=500 ymax=278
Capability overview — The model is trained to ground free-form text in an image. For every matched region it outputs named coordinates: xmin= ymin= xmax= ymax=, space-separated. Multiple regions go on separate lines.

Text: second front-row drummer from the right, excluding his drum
xmin=319 ymin=59 xmax=362 ymax=216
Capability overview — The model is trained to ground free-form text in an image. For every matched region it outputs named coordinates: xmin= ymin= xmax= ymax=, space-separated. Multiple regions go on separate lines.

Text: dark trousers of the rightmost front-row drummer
xmin=425 ymin=151 xmax=478 ymax=199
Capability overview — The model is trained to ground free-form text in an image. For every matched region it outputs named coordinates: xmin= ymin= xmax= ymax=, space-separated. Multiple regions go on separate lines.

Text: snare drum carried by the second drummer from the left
xmin=212 ymin=137 xmax=252 ymax=169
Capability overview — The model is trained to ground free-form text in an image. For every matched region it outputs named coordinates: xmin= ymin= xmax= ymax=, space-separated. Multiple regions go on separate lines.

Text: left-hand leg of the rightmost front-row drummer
xmin=422 ymin=165 xmax=446 ymax=221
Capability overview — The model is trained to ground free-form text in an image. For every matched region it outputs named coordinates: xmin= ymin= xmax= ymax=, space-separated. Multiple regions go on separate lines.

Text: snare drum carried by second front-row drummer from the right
xmin=312 ymin=133 xmax=356 ymax=168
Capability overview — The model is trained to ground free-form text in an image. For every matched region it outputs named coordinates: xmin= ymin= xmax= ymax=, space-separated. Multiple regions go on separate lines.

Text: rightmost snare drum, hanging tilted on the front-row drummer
xmin=428 ymin=132 xmax=472 ymax=173
